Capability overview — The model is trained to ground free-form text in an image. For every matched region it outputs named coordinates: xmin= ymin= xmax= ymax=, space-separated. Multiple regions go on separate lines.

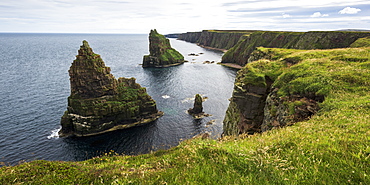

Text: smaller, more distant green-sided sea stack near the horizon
xmin=143 ymin=29 xmax=184 ymax=67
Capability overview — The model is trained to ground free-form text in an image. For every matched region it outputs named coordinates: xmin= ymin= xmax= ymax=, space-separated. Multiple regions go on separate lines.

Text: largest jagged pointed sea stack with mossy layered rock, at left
xmin=59 ymin=41 xmax=163 ymax=136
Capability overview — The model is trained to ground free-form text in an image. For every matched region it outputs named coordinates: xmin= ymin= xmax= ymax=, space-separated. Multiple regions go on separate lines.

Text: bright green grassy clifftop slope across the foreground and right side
xmin=0 ymin=48 xmax=370 ymax=184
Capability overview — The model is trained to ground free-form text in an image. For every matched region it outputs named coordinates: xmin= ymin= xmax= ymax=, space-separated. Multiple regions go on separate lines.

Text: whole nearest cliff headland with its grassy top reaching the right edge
xmin=224 ymin=47 xmax=370 ymax=135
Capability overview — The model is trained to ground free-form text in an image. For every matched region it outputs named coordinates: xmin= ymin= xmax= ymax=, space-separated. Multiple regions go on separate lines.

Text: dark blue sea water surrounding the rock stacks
xmin=0 ymin=33 xmax=236 ymax=165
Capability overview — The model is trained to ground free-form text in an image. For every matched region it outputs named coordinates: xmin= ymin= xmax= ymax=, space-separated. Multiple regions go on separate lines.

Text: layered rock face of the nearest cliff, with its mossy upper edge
xmin=223 ymin=48 xmax=330 ymax=135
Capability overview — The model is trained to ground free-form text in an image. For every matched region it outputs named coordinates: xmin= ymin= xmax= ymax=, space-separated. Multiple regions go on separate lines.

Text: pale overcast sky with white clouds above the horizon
xmin=0 ymin=0 xmax=370 ymax=34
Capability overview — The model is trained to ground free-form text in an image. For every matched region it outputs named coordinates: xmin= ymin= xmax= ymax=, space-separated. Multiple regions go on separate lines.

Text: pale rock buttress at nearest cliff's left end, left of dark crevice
xmin=224 ymin=66 xmax=272 ymax=135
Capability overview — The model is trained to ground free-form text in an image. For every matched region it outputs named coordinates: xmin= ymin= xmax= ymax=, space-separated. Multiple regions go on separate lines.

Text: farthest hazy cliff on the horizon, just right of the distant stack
xmin=178 ymin=30 xmax=255 ymax=50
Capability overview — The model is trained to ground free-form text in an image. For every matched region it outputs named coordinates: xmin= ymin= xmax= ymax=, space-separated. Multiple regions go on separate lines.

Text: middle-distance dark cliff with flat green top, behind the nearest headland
xmin=221 ymin=31 xmax=370 ymax=66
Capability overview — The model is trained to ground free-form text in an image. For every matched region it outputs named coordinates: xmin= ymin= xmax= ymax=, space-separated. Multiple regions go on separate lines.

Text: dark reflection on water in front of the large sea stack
xmin=61 ymin=121 xmax=157 ymax=161
